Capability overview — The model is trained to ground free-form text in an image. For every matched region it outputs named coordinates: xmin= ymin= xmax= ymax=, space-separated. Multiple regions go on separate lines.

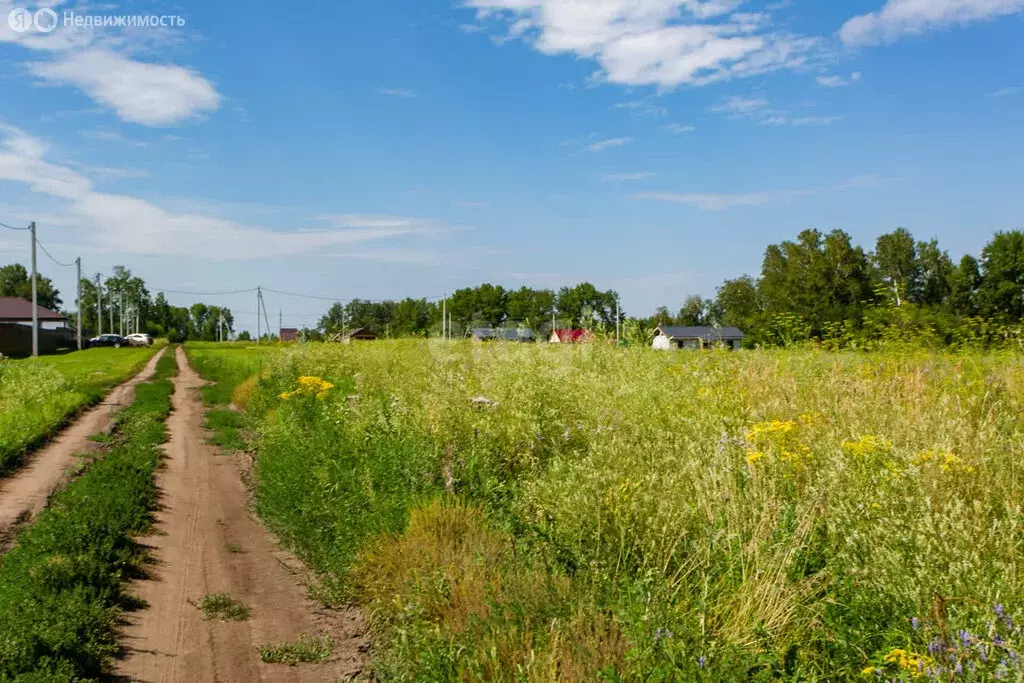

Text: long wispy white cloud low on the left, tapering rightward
xmin=0 ymin=124 xmax=446 ymax=260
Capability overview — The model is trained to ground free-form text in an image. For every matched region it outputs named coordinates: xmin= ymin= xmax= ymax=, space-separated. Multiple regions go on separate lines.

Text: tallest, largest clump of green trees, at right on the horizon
xmin=647 ymin=228 xmax=1024 ymax=347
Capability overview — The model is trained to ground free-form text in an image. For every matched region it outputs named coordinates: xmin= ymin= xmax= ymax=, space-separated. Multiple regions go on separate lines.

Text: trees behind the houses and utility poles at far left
xmin=0 ymin=263 xmax=234 ymax=342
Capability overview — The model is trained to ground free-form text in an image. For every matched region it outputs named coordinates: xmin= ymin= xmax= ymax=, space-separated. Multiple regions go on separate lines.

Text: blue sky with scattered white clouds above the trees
xmin=0 ymin=0 xmax=1024 ymax=328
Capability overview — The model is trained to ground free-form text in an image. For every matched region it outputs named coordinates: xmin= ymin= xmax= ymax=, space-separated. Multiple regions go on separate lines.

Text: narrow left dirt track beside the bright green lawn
xmin=0 ymin=349 xmax=166 ymax=552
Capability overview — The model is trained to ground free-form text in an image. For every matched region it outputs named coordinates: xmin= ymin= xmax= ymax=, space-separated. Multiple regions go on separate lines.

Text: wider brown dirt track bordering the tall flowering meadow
xmin=116 ymin=348 xmax=366 ymax=682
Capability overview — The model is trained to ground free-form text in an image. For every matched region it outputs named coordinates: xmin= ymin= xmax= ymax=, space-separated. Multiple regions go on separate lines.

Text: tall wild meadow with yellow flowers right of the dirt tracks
xmin=186 ymin=340 xmax=1024 ymax=681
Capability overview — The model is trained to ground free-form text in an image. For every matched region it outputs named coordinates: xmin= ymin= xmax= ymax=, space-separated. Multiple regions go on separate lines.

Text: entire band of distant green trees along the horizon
xmin=0 ymin=228 xmax=1024 ymax=347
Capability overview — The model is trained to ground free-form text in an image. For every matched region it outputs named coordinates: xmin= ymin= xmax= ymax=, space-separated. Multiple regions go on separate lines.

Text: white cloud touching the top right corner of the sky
xmin=839 ymin=0 xmax=1024 ymax=46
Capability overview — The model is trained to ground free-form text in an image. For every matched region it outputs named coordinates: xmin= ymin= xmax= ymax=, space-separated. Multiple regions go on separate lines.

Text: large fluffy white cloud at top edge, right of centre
xmin=466 ymin=0 xmax=819 ymax=88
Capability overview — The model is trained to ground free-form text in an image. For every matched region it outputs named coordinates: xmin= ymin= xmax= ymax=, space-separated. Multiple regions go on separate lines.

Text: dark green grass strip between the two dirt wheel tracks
xmin=0 ymin=349 xmax=172 ymax=681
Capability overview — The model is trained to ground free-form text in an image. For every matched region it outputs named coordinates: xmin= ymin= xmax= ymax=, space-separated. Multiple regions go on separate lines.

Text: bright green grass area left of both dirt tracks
xmin=0 ymin=347 xmax=159 ymax=476
